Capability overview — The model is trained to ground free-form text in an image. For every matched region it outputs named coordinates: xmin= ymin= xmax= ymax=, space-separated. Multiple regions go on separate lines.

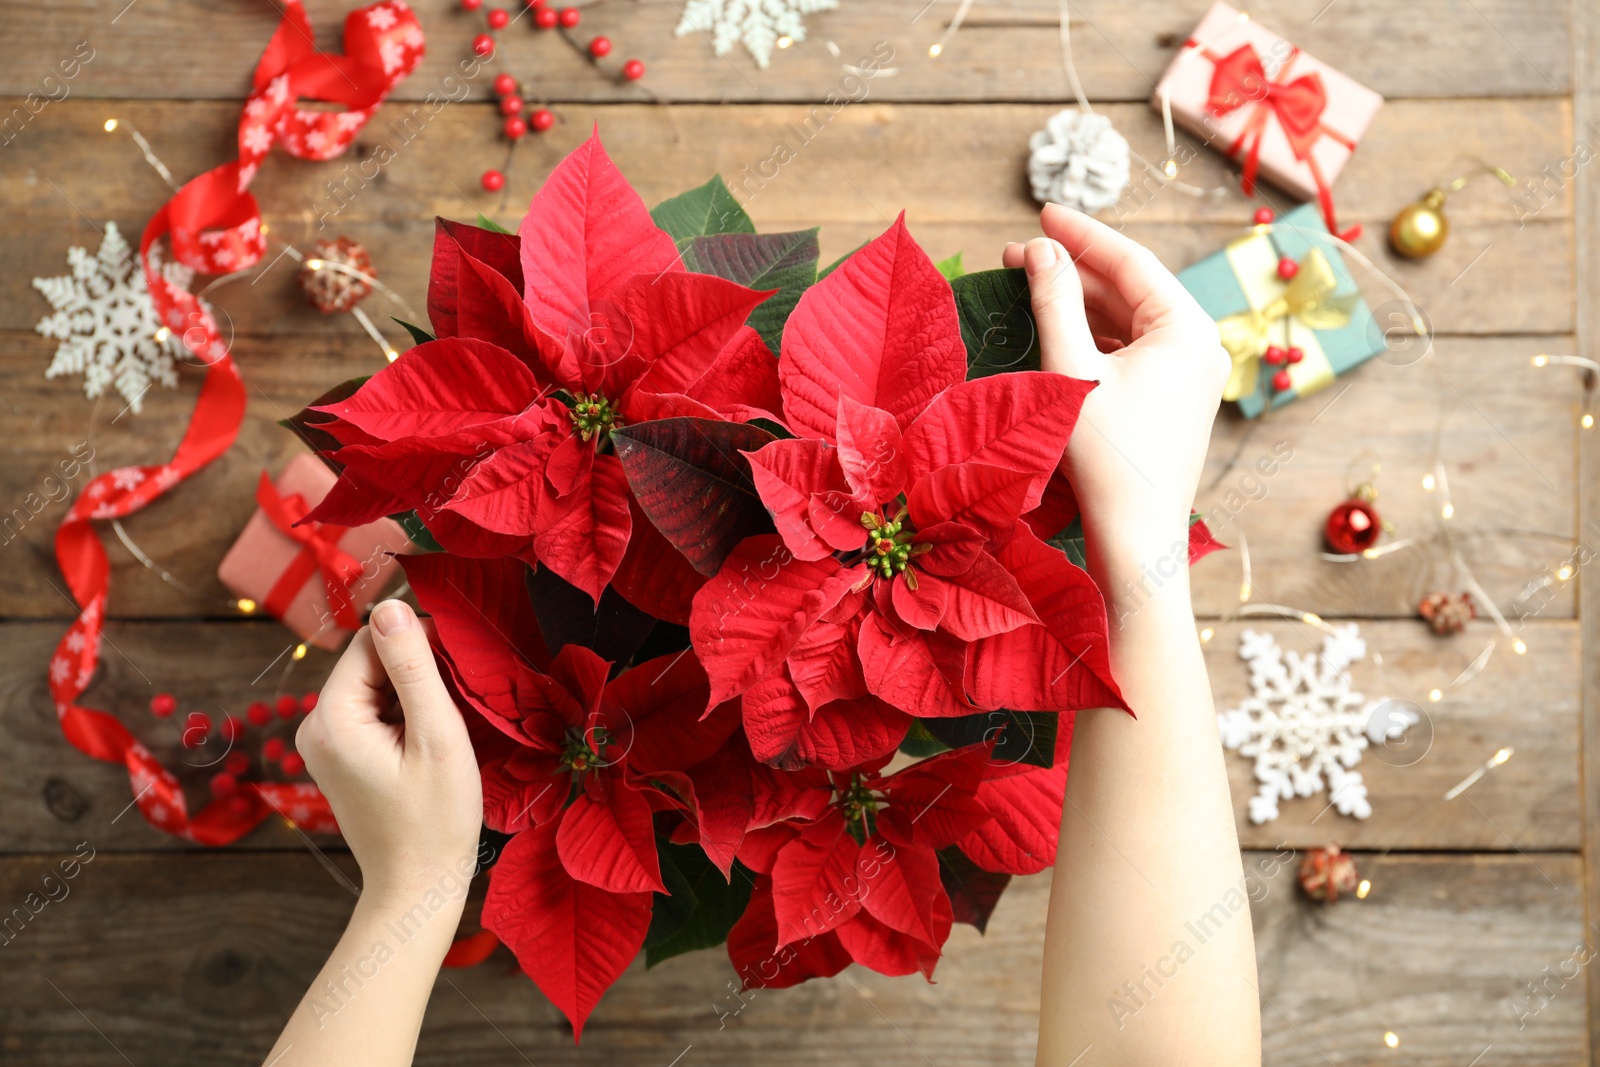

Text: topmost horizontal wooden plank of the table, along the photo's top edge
xmin=0 ymin=0 xmax=1570 ymax=101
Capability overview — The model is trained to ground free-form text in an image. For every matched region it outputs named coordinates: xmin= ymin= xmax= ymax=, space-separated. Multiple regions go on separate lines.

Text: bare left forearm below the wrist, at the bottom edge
xmin=266 ymin=889 xmax=462 ymax=1067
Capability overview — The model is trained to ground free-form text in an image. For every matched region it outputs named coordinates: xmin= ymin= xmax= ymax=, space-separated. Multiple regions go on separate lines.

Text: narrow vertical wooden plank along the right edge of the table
xmin=1558 ymin=3 xmax=1600 ymax=1048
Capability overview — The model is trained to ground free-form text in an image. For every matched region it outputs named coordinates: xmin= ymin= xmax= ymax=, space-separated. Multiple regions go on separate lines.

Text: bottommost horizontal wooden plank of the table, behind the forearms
xmin=0 ymin=853 xmax=1587 ymax=1067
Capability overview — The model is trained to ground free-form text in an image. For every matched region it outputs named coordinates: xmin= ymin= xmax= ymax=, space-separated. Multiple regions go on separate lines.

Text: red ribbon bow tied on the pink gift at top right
xmin=1190 ymin=42 xmax=1362 ymax=242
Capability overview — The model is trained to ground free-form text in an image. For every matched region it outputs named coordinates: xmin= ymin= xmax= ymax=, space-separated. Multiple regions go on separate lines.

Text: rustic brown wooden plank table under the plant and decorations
xmin=0 ymin=0 xmax=1600 ymax=1067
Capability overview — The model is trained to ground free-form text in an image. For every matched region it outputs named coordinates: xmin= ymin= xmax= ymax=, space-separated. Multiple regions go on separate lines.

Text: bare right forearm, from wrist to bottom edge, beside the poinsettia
xmin=1038 ymin=526 xmax=1261 ymax=1067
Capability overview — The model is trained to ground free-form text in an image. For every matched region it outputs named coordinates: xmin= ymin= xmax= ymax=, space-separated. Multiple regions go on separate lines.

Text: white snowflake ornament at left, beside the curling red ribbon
xmin=34 ymin=222 xmax=194 ymax=413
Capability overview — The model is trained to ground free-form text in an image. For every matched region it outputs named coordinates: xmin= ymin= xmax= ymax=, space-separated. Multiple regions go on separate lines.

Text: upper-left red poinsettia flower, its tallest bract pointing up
xmin=302 ymin=133 xmax=776 ymax=608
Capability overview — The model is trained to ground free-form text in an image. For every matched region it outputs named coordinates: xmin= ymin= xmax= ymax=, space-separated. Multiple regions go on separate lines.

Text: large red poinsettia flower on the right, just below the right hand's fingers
xmin=690 ymin=219 xmax=1122 ymax=769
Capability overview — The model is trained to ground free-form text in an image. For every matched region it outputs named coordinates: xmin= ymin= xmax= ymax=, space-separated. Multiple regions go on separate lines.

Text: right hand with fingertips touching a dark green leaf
xmin=1003 ymin=205 xmax=1229 ymax=573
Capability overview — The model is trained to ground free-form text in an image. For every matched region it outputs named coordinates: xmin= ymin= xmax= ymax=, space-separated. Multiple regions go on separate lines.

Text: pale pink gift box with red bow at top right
xmin=1150 ymin=0 xmax=1384 ymax=234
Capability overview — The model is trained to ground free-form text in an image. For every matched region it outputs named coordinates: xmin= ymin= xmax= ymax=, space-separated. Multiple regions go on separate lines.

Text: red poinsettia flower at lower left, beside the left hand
xmin=405 ymin=553 xmax=738 ymax=1035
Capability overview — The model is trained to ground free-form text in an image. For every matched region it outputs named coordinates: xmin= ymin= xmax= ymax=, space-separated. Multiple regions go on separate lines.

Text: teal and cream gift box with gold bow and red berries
xmin=1178 ymin=203 xmax=1386 ymax=419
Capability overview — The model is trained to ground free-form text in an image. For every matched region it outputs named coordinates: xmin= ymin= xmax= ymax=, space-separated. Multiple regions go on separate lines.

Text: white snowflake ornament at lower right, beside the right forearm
xmin=1216 ymin=622 xmax=1418 ymax=825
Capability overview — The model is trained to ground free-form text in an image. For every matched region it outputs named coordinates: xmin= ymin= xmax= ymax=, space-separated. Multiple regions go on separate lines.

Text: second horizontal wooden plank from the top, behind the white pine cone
xmin=0 ymin=99 xmax=1573 ymax=334
